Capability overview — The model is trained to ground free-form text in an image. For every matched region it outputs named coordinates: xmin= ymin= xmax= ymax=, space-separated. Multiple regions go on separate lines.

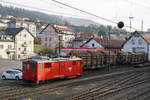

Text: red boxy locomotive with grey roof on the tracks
xmin=22 ymin=57 xmax=82 ymax=83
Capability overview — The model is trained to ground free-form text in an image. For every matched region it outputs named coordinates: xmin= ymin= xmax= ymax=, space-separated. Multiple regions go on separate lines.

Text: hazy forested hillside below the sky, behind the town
xmin=0 ymin=4 xmax=127 ymax=36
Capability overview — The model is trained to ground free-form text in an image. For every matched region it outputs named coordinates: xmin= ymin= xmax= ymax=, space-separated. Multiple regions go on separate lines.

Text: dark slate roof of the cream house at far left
xmin=0 ymin=27 xmax=24 ymax=36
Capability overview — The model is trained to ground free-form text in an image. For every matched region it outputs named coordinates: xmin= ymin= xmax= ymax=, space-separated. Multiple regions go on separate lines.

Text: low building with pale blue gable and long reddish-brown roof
xmin=80 ymin=38 xmax=124 ymax=53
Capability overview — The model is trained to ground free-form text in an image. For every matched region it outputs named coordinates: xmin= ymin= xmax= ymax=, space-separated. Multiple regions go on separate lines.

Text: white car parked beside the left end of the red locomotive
xmin=2 ymin=69 xmax=22 ymax=80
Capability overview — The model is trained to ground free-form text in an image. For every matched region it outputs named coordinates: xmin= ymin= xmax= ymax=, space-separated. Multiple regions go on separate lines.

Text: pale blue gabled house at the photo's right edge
xmin=123 ymin=31 xmax=150 ymax=61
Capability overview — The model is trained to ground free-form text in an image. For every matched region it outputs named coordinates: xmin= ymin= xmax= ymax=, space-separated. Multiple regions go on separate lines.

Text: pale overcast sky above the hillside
xmin=1 ymin=0 xmax=150 ymax=31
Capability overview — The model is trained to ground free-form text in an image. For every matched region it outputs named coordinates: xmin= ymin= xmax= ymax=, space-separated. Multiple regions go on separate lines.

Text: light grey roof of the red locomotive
xmin=24 ymin=57 xmax=81 ymax=62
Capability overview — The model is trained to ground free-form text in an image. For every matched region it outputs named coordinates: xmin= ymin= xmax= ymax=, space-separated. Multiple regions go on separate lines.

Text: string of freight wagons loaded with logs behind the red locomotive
xmin=68 ymin=50 xmax=147 ymax=69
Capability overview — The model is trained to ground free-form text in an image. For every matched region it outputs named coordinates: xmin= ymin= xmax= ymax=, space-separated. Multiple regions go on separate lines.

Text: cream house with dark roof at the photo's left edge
xmin=0 ymin=28 xmax=34 ymax=59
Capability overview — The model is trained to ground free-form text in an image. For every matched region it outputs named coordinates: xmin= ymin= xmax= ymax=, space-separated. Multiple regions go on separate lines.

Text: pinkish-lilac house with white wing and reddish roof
xmin=40 ymin=24 xmax=75 ymax=49
